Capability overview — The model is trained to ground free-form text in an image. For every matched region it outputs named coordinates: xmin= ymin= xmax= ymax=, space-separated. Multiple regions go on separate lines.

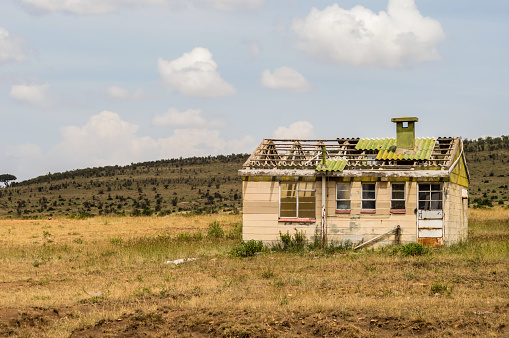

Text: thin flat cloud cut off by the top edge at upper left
xmin=18 ymin=0 xmax=181 ymax=15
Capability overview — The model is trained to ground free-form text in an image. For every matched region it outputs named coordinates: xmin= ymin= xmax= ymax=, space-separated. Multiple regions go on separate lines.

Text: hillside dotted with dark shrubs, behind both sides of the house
xmin=0 ymin=136 xmax=509 ymax=218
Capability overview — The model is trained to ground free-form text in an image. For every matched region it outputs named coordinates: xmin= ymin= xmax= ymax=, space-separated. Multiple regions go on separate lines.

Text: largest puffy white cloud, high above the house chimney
xmin=292 ymin=0 xmax=445 ymax=67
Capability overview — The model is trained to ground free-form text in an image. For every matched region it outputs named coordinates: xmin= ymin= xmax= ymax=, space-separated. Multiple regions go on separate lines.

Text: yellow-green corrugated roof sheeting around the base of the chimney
xmin=355 ymin=137 xmax=436 ymax=161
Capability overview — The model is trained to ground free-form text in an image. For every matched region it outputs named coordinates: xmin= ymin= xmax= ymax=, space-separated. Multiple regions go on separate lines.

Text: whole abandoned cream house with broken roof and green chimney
xmin=239 ymin=117 xmax=470 ymax=247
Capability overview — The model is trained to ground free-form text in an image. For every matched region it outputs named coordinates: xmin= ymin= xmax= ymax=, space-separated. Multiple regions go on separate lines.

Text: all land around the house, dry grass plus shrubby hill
xmin=0 ymin=139 xmax=509 ymax=337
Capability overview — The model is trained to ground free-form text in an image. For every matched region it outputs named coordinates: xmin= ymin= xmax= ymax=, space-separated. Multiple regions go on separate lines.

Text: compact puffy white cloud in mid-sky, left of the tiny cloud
xmin=157 ymin=47 xmax=235 ymax=97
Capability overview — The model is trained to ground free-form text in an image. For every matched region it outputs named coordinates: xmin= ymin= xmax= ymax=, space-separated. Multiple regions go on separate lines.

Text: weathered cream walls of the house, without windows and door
xmin=242 ymin=178 xmax=468 ymax=245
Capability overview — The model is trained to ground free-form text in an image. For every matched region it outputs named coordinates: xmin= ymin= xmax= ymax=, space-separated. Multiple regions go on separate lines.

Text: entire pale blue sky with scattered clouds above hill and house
xmin=0 ymin=0 xmax=509 ymax=181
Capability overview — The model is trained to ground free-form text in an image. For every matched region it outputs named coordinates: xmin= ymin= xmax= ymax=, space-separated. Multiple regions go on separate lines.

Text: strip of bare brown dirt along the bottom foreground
xmin=0 ymin=297 xmax=509 ymax=337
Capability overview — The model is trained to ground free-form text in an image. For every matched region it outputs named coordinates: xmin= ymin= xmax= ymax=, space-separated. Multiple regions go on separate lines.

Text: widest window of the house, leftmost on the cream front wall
xmin=279 ymin=182 xmax=316 ymax=218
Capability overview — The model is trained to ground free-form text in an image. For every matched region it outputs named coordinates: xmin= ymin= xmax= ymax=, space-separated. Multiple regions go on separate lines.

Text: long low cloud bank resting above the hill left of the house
xmin=0 ymin=111 xmax=257 ymax=181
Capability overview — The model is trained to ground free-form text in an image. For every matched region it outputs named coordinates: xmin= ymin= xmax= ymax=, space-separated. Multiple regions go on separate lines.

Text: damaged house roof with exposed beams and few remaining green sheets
xmin=242 ymin=137 xmax=462 ymax=173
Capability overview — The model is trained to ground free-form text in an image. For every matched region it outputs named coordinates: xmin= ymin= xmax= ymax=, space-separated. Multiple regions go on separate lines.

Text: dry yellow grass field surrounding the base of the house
xmin=0 ymin=208 xmax=509 ymax=337
